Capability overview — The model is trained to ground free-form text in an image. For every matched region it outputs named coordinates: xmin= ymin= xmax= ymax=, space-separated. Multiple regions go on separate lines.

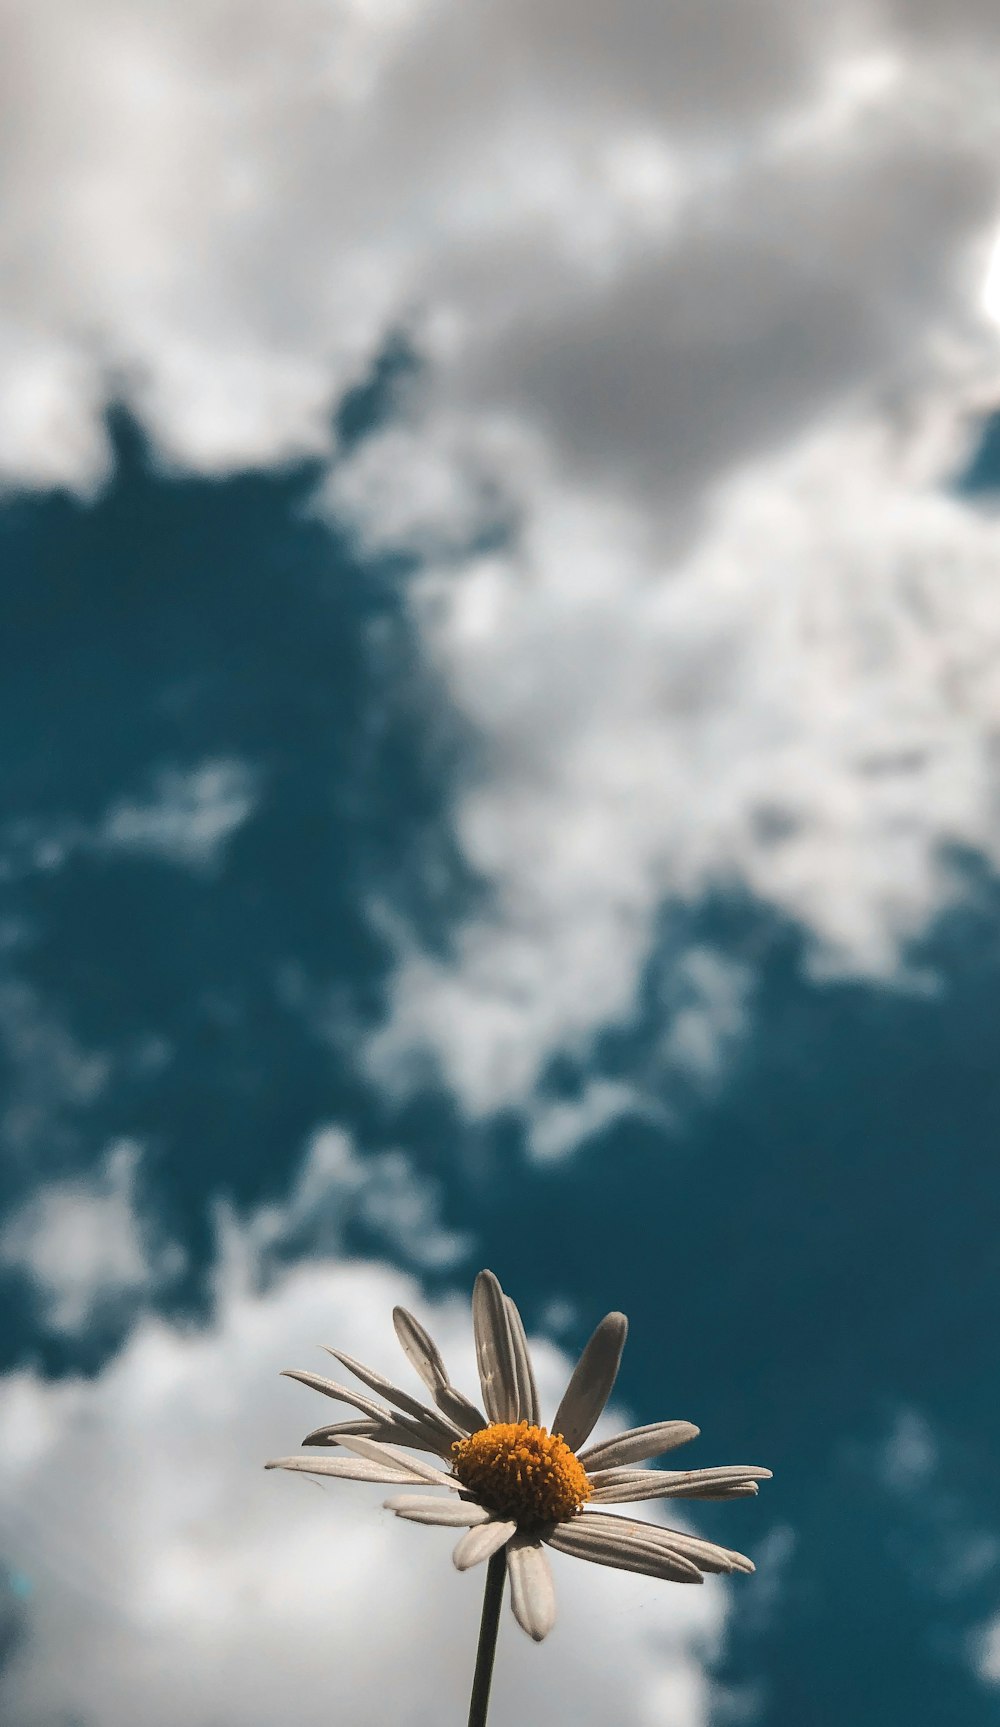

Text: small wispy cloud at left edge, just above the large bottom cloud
xmin=0 ymin=1140 xmax=185 ymax=1337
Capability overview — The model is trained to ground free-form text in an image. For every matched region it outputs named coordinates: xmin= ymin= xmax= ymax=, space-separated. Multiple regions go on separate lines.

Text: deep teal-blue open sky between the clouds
xmin=0 ymin=404 xmax=1000 ymax=1727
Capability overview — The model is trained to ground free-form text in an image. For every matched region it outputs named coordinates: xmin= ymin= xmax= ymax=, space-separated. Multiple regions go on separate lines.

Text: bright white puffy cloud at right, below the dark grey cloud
xmin=359 ymin=418 xmax=1000 ymax=1110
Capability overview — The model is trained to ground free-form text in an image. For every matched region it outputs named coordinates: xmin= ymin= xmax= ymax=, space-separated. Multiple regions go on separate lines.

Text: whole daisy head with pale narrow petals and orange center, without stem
xmin=268 ymin=1271 xmax=770 ymax=1641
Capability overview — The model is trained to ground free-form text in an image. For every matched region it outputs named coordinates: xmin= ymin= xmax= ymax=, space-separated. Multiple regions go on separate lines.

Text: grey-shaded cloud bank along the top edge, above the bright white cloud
xmin=0 ymin=0 xmax=1000 ymax=497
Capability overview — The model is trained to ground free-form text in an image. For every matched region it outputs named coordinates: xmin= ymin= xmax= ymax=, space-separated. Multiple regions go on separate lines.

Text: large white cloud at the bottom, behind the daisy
xmin=0 ymin=1254 xmax=727 ymax=1727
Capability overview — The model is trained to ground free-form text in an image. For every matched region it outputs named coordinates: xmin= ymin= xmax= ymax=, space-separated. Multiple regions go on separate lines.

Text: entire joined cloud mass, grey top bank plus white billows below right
xmin=0 ymin=0 xmax=1000 ymax=1119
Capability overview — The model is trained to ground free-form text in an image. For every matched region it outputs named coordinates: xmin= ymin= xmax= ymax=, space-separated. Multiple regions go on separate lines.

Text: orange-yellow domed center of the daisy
xmin=451 ymin=1421 xmax=592 ymax=1528
